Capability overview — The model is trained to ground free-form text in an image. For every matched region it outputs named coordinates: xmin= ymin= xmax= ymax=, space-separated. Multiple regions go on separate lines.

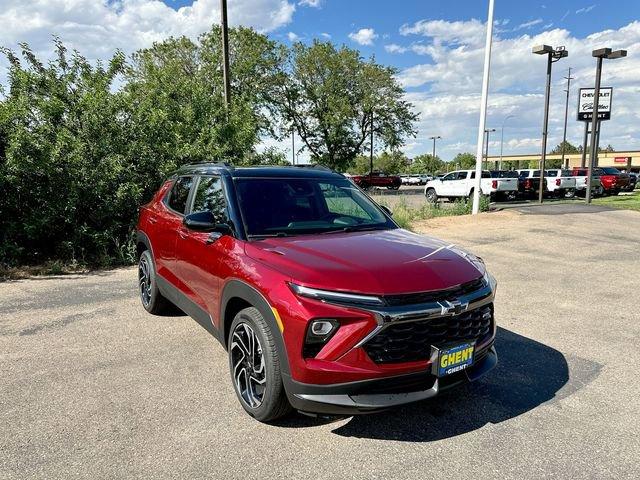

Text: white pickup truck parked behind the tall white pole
xmin=424 ymin=170 xmax=518 ymax=203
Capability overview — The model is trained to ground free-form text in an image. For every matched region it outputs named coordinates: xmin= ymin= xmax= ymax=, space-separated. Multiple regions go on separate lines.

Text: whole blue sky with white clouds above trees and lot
xmin=0 ymin=0 xmax=640 ymax=159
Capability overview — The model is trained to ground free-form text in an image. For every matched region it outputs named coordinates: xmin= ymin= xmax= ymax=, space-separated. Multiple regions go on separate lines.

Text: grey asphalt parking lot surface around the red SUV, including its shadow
xmin=0 ymin=205 xmax=640 ymax=479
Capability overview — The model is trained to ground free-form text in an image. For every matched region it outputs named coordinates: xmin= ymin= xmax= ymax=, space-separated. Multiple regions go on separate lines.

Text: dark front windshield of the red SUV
xmin=235 ymin=178 xmax=396 ymax=237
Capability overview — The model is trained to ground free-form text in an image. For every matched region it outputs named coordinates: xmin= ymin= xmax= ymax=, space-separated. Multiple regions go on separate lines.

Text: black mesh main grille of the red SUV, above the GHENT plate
xmin=364 ymin=304 xmax=493 ymax=363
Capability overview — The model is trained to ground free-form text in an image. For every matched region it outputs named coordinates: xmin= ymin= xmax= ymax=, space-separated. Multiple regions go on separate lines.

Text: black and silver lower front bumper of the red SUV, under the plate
xmin=283 ymin=346 xmax=498 ymax=415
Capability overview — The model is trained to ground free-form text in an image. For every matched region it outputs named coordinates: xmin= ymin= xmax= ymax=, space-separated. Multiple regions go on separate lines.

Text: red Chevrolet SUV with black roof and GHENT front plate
xmin=138 ymin=164 xmax=497 ymax=421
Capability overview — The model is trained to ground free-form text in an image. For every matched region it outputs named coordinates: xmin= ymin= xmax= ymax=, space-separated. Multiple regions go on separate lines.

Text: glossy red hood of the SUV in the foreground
xmin=246 ymin=229 xmax=484 ymax=295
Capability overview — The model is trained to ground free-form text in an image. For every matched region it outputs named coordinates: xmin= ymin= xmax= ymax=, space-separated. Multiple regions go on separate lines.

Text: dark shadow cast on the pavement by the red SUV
xmin=278 ymin=328 xmax=601 ymax=442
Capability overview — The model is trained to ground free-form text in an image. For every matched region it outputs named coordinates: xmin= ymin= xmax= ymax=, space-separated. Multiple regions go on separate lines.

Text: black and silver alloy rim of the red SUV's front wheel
xmin=231 ymin=323 xmax=267 ymax=408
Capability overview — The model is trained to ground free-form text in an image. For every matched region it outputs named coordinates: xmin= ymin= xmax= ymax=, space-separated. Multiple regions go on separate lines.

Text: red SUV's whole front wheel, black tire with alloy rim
xmin=228 ymin=307 xmax=291 ymax=422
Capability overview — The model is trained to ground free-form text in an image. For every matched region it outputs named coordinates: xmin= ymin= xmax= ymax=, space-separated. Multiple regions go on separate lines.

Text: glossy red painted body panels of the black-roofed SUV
xmin=138 ymin=165 xmax=495 ymax=412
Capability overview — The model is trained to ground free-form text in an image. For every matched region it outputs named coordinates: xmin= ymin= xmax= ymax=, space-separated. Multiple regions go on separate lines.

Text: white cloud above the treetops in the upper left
xmin=0 ymin=0 xmax=295 ymax=65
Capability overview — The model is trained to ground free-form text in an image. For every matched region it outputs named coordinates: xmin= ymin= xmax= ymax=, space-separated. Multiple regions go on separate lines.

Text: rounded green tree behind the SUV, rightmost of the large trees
xmin=276 ymin=41 xmax=417 ymax=171
